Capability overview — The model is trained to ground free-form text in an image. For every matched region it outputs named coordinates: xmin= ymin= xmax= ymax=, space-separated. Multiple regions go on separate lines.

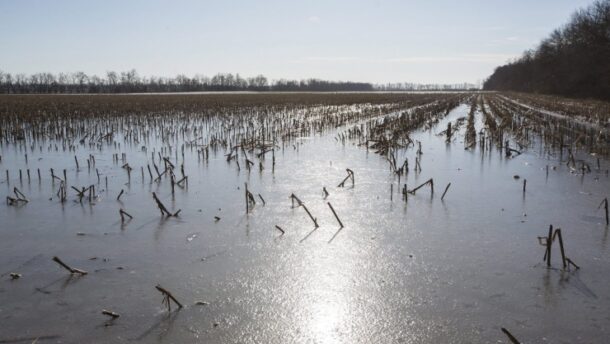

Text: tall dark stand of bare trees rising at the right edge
xmin=483 ymin=0 xmax=610 ymax=100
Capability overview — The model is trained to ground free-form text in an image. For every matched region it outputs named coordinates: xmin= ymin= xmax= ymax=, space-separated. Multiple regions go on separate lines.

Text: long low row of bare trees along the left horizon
xmin=0 ymin=69 xmax=373 ymax=94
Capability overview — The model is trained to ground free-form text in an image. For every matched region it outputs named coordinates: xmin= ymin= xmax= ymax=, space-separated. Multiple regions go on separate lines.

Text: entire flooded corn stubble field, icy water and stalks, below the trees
xmin=0 ymin=93 xmax=610 ymax=343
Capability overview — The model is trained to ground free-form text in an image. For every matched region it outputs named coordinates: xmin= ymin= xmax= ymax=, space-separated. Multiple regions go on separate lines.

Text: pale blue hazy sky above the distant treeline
xmin=0 ymin=0 xmax=593 ymax=83
